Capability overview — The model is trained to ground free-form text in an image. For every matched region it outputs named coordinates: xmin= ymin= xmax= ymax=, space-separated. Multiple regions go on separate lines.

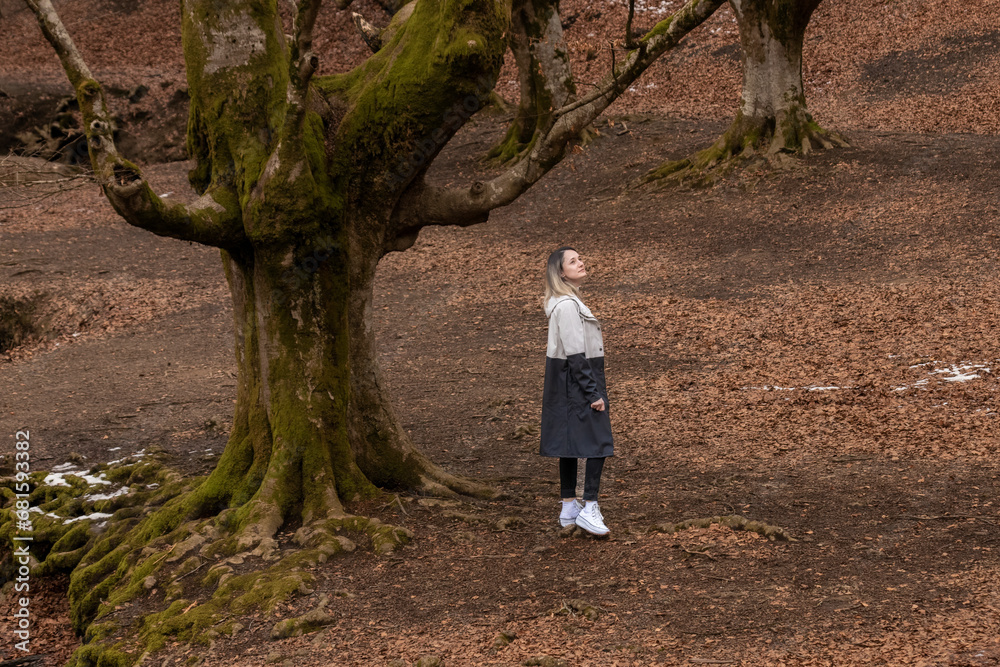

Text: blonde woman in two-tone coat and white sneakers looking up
xmin=539 ymin=247 xmax=614 ymax=535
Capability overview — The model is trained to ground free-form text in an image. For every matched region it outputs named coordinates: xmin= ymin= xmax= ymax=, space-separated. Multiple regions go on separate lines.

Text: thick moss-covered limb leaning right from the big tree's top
xmin=314 ymin=0 xmax=511 ymax=224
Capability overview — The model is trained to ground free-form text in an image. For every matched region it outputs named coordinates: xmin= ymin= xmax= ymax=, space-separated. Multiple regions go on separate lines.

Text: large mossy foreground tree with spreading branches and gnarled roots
xmin=19 ymin=0 xmax=724 ymax=664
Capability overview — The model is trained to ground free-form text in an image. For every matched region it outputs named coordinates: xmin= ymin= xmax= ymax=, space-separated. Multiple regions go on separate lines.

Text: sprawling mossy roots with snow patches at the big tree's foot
xmin=0 ymin=460 xmax=414 ymax=667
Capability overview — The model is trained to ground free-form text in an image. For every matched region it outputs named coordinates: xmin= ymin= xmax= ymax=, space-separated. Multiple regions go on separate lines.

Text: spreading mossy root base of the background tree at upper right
xmin=642 ymin=110 xmax=850 ymax=188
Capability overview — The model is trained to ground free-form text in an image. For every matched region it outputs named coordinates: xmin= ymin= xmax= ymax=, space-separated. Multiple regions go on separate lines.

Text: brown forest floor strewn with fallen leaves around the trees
xmin=0 ymin=2 xmax=1000 ymax=666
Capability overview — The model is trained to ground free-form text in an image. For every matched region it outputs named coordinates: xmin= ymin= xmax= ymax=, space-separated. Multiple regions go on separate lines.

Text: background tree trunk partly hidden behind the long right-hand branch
xmin=489 ymin=0 xmax=576 ymax=162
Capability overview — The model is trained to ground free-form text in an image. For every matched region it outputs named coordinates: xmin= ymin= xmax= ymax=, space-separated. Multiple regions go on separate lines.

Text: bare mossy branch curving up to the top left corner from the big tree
xmin=25 ymin=0 xmax=242 ymax=247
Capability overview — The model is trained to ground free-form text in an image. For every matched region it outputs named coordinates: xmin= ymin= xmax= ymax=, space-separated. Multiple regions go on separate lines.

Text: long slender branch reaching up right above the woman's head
xmin=396 ymin=0 xmax=726 ymax=230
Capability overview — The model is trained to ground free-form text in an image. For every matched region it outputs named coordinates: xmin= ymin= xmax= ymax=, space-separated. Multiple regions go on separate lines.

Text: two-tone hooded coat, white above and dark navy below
xmin=539 ymin=296 xmax=614 ymax=458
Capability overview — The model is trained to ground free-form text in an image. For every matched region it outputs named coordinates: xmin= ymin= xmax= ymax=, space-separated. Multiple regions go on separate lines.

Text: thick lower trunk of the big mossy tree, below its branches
xmin=192 ymin=236 xmax=364 ymax=532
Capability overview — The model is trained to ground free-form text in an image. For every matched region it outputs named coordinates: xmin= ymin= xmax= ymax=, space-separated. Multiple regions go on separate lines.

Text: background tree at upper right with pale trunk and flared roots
xmin=645 ymin=0 xmax=847 ymax=185
